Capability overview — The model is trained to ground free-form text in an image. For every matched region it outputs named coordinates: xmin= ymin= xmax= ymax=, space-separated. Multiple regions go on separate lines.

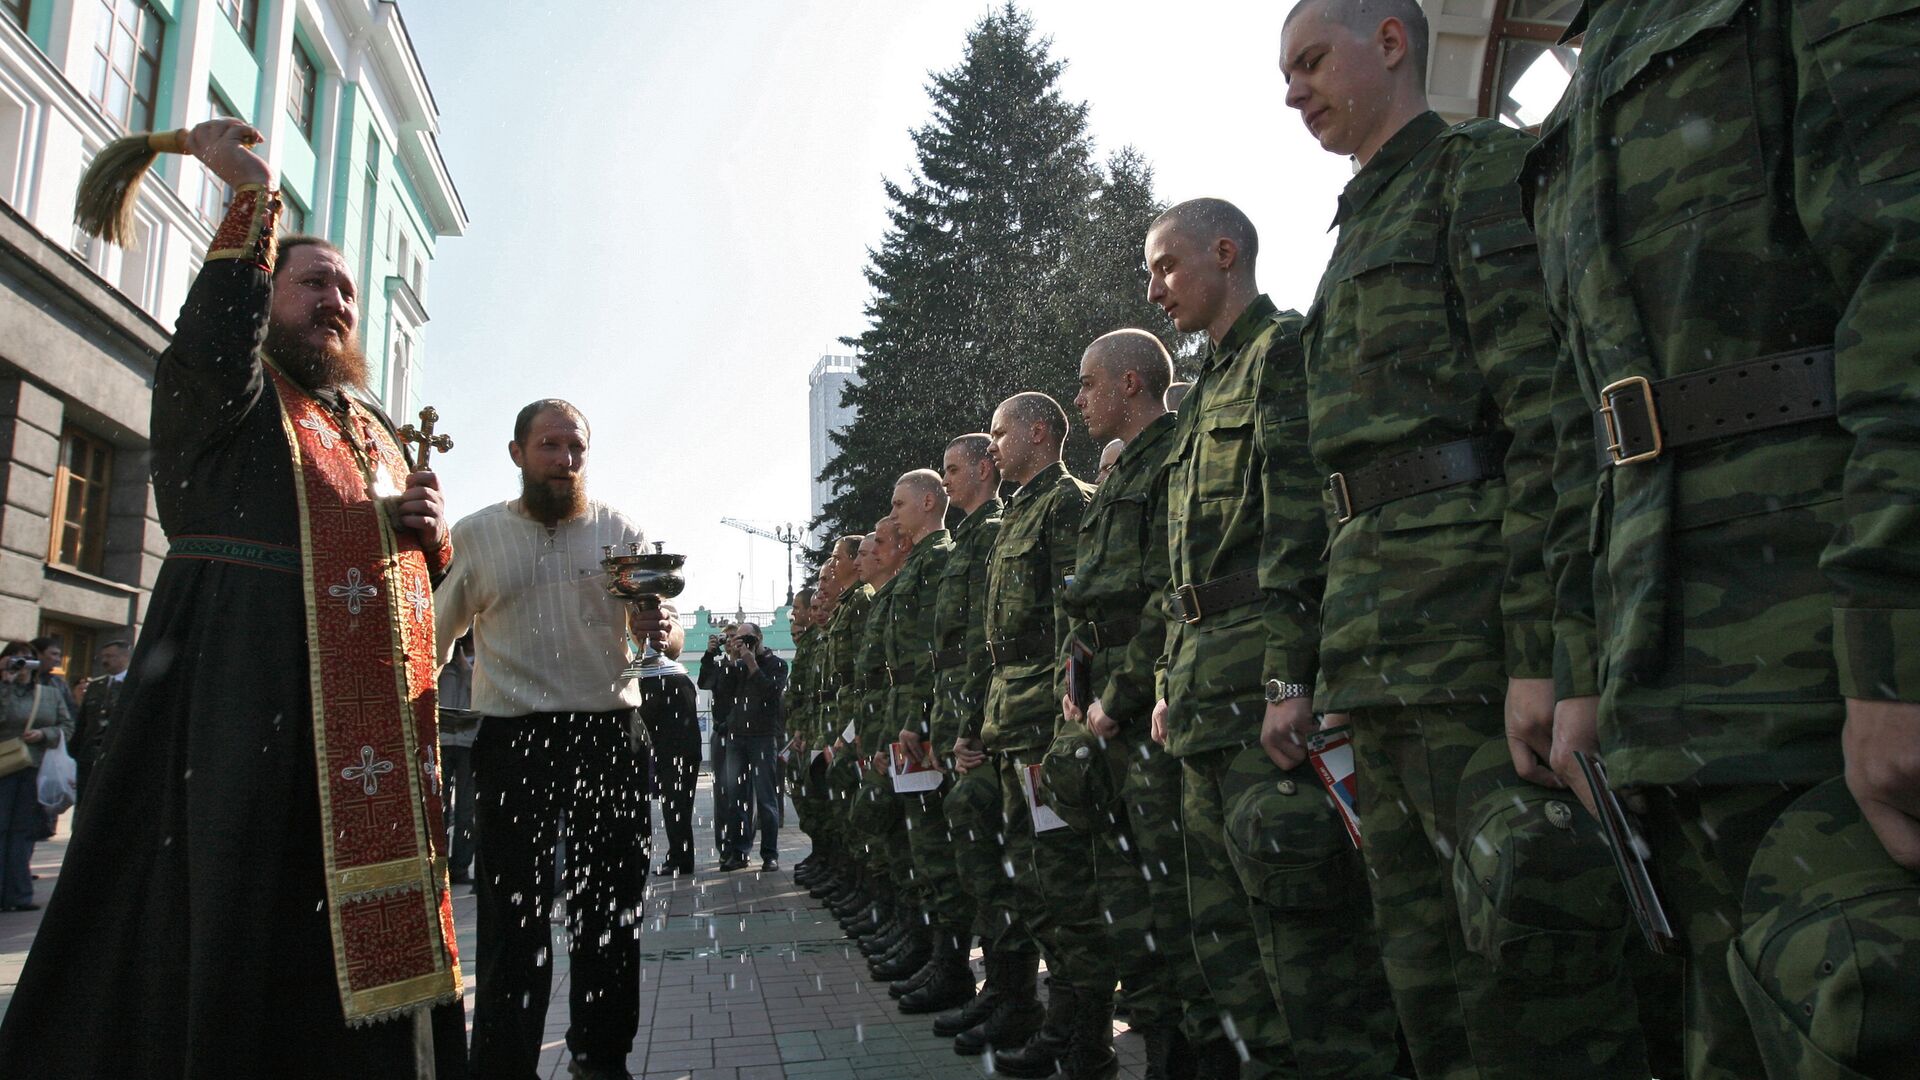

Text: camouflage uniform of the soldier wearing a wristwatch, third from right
xmin=1152 ymin=296 xmax=1394 ymax=1076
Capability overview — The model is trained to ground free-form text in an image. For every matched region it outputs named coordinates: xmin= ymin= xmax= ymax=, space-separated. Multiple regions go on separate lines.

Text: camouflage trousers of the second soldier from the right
xmin=1352 ymin=703 xmax=1649 ymax=1080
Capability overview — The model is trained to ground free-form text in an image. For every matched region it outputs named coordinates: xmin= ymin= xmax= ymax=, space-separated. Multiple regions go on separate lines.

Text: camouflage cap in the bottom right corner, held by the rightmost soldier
xmin=1728 ymin=776 xmax=1920 ymax=1078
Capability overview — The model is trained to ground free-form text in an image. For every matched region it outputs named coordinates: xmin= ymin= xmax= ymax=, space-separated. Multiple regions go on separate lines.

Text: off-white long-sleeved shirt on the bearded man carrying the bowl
xmin=434 ymin=500 xmax=645 ymax=717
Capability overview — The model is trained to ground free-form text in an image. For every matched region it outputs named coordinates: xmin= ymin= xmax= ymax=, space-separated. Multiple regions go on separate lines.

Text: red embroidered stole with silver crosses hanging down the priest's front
xmin=269 ymin=365 xmax=461 ymax=1024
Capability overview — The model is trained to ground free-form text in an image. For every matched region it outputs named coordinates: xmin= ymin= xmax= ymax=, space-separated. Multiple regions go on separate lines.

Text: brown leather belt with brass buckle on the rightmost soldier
xmin=1594 ymin=346 xmax=1836 ymax=465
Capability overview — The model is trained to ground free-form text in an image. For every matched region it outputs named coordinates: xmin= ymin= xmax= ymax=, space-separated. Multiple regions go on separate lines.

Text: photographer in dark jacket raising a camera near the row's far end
xmin=720 ymin=623 xmax=787 ymax=871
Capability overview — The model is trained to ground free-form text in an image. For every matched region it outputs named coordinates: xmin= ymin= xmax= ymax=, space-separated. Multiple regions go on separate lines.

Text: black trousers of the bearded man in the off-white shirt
xmin=472 ymin=709 xmax=651 ymax=1080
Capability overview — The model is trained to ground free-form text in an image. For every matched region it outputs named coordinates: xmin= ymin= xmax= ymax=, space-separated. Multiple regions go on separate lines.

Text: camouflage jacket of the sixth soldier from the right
xmin=929 ymin=498 xmax=1004 ymax=759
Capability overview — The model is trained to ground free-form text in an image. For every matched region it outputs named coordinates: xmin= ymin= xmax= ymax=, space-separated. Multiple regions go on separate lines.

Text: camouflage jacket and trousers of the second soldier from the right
xmin=1302 ymin=113 xmax=1647 ymax=1076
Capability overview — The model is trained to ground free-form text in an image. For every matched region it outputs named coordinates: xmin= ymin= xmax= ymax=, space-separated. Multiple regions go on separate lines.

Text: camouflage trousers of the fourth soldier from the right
xmin=1092 ymin=726 xmax=1190 ymax=1038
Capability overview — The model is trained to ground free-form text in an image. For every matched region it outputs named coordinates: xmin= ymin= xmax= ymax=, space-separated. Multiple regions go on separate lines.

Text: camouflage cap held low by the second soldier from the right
xmin=1453 ymin=736 xmax=1628 ymax=960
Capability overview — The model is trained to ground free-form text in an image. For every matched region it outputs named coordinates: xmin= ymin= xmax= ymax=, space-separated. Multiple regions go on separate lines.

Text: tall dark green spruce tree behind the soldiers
xmin=814 ymin=4 xmax=1171 ymax=557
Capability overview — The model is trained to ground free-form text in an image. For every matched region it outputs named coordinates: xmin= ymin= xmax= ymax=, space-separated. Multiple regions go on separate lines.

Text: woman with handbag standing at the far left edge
xmin=0 ymin=642 xmax=73 ymax=911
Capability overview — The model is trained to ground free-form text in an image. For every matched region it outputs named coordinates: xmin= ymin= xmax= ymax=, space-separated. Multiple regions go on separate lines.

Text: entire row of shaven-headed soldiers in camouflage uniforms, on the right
xmin=791 ymin=0 xmax=1920 ymax=1080
